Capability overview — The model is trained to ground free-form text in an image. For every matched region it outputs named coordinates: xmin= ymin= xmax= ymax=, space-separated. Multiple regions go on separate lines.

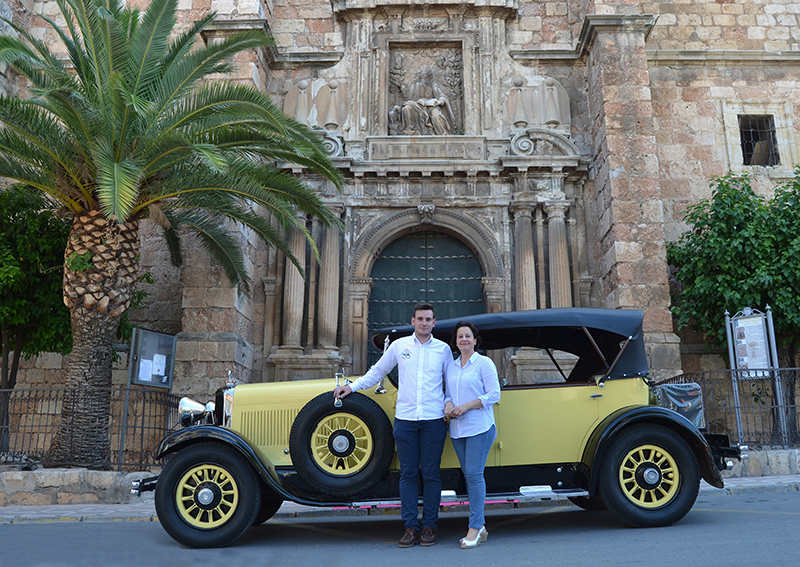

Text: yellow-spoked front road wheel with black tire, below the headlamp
xmin=155 ymin=443 xmax=261 ymax=547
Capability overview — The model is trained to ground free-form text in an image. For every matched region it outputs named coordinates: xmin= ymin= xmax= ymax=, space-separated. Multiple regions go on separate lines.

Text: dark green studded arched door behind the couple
xmin=368 ymin=232 xmax=486 ymax=366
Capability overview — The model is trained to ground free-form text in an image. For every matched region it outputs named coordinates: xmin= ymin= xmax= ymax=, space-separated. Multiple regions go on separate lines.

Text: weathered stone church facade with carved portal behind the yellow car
xmin=0 ymin=0 xmax=800 ymax=396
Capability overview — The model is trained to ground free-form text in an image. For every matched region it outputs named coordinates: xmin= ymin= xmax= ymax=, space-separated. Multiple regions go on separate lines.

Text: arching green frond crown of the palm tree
xmin=0 ymin=0 xmax=342 ymax=290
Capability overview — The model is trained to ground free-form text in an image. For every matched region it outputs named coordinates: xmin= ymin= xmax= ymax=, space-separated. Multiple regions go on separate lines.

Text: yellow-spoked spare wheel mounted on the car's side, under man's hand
xmin=289 ymin=392 xmax=394 ymax=498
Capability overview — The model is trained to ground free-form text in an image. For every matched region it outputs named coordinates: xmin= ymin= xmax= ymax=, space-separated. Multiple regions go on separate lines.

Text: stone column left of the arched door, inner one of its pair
xmin=317 ymin=205 xmax=344 ymax=349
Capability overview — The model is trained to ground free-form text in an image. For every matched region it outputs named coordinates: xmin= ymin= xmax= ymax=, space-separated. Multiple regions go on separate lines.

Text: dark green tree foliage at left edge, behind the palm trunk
xmin=0 ymin=186 xmax=72 ymax=386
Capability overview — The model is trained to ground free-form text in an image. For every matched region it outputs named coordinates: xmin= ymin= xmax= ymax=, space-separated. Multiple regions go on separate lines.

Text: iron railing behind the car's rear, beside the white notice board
xmin=662 ymin=368 xmax=800 ymax=448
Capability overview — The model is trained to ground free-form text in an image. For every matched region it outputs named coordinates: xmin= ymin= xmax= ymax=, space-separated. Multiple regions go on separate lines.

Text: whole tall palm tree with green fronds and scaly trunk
xmin=0 ymin=0 xmax=341 ymax=465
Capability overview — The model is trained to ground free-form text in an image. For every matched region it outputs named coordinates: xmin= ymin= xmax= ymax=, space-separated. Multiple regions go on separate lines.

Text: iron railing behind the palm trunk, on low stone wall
xmin=0 ymin=387 xmax=180 ymax=471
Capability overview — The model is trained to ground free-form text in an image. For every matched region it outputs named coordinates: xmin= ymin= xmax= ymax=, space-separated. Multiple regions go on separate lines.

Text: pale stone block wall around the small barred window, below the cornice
xmin=650 ymin=63 xmax=800 ymax=241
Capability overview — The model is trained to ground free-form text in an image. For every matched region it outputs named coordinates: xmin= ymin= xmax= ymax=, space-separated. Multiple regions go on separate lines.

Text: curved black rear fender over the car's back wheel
xmin=582 ymin=406 xmax=724 ymax=494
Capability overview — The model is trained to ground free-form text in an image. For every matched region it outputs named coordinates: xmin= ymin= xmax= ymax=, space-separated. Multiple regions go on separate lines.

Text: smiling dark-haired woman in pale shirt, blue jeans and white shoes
xmin=444 ymin=321 xmax=500 ymax=549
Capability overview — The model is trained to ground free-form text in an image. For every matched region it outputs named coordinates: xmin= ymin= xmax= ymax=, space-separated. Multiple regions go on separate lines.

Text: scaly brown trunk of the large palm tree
xmin=48 ymin=210 xmax=139 ymax=468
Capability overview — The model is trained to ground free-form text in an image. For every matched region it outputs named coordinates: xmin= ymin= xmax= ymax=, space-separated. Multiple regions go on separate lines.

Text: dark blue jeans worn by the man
xmin=394 ymin=419 xmax=447 ymax=531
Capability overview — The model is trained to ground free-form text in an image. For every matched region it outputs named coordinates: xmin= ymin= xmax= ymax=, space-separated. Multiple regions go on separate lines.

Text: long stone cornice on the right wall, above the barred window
xmin=647 ymin=49 xmax=800 ymax=67
